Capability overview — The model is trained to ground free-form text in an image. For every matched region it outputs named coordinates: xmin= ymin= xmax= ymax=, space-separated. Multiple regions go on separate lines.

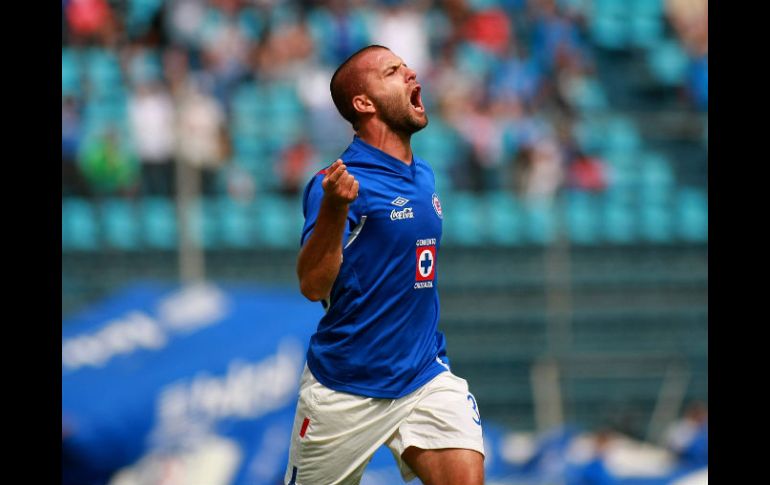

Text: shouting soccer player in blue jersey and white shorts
xmin=285 ymin=45 xmax=484 ymax=485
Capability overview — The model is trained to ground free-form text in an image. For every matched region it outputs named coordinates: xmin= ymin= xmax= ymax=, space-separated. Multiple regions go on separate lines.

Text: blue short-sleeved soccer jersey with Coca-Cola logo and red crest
xmin=302 ymin=136 xmax=448 ymax=399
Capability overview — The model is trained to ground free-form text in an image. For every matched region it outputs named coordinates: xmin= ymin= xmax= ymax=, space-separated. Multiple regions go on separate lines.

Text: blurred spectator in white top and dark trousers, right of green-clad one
xmin=128 ymin=83 xmax=174 ymax=196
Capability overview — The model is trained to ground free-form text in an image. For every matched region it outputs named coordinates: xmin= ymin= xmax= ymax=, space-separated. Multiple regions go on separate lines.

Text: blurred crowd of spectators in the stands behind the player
xmin=62 ymin=0 xmax=707 ymax=202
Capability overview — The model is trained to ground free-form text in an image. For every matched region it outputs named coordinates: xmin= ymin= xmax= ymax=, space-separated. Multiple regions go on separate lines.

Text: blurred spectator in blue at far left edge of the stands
xmin=61 ymin=96 xmax=88 ymax=197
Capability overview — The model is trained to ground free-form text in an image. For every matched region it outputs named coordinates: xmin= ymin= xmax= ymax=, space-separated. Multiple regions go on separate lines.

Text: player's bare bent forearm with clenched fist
xmin=297 ymin=159 xmax=358 ymax=301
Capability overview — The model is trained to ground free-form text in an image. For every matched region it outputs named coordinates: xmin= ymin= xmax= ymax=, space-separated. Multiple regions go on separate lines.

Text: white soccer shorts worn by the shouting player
xmin=284 ymin=365 xmax=484 ymax=485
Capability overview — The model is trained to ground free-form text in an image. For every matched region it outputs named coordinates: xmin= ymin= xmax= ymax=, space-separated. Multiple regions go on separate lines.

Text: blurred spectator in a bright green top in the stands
xmin=78 ymin=125 xmax=139 ymax=197
